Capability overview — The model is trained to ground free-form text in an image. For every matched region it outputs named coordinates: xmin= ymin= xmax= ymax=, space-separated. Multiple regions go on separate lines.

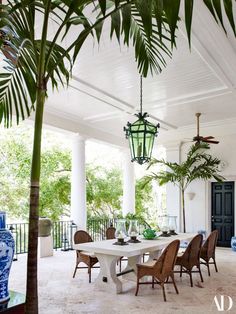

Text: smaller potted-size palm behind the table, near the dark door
xmin=144 ymin=143 xmax=224 ymax=232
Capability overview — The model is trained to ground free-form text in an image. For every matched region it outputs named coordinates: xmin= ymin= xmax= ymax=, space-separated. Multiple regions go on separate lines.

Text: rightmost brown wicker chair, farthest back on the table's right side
xmin=200 ymin=230 xmax=218 ymax=276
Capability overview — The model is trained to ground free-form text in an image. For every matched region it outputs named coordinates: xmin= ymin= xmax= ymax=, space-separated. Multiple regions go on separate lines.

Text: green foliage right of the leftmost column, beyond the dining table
xmin=86 ymin=165 xmax=153 ymax=218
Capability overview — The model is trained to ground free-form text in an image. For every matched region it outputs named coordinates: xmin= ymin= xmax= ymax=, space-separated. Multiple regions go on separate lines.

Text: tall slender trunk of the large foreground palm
xmin=25 ymin=86 xmax=46 ymax=314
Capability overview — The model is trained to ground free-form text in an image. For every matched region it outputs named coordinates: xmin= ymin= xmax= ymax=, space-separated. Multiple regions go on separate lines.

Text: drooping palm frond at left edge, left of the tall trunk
xmin=0 ymin=36 xmax=37 ymax=127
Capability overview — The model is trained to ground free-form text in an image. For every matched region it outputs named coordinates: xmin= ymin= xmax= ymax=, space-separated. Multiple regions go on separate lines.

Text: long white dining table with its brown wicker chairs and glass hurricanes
xmin=73 ymin=216 xmax=218 ymax=301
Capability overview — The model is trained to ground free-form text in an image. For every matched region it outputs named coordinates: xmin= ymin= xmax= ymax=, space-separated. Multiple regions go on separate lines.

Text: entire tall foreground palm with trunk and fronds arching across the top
xmin=0 ymin=0 xmax=235 ymax=314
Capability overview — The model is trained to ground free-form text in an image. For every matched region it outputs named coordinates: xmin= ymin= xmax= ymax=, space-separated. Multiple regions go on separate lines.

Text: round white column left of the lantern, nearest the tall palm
xmin=71 ymin=135 xmax=87 ymax=230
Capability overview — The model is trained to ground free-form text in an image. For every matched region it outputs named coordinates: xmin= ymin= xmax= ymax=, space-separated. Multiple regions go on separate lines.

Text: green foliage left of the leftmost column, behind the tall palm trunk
xmin=0 ymin=129 xmax=71 ymax=221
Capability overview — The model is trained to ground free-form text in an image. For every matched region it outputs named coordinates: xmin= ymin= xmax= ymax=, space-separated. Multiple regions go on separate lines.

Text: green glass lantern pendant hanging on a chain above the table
xmin=124 ymin=76 xmax=160 ymax=165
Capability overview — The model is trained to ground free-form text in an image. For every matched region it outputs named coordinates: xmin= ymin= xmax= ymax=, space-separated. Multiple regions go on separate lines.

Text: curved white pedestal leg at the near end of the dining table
xmin=95 ymin=253 xmax=122 ymax=293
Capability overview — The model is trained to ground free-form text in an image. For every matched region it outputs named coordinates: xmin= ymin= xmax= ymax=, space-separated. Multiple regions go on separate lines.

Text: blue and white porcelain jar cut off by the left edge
xmin=0 ymin=211 xmax=15 ymax=303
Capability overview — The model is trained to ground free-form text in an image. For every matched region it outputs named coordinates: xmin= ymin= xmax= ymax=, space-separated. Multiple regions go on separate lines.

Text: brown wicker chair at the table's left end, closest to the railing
xmin=73 ymin=230 xmax=99 ymax=283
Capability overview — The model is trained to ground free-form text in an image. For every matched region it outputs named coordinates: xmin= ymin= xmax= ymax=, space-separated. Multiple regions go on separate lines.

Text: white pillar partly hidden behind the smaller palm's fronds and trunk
xmin=165 ymin=143 xmax=182 ymax=231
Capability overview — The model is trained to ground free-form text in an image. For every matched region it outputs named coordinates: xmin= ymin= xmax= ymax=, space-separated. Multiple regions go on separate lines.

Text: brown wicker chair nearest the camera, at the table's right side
xmin=135 ymin=240 xmax=180 ymax=301
